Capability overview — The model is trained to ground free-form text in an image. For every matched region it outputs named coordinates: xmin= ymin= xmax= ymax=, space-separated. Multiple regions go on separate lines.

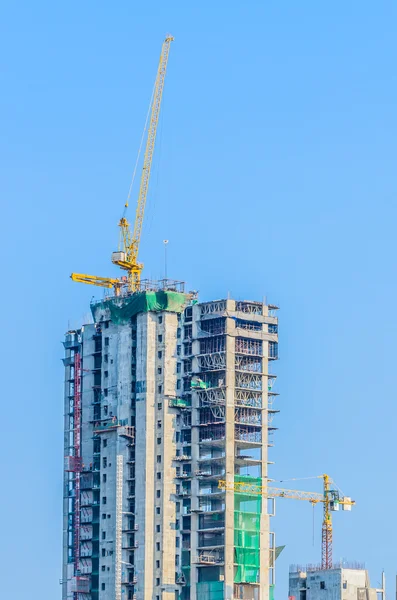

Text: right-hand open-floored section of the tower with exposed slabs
xmin=169 ymin=300 xmax=278 ymax=600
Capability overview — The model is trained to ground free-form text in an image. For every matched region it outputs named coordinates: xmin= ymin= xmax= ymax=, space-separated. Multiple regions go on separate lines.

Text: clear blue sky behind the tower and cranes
xmin=0 ymin=0 xmax=397 ymax=600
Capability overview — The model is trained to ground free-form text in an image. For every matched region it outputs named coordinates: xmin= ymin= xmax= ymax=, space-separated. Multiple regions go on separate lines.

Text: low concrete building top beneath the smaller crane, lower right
xmin=288 ymin=561 xmax=386 ymax=600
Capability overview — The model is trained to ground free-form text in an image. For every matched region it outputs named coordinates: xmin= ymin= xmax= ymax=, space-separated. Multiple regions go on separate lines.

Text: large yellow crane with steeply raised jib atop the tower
xmin=71 ymin=35 xmax=174 ymax=296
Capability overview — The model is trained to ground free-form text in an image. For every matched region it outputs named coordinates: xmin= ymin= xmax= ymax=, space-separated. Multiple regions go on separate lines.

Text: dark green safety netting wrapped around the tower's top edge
xmin=91 ymin=291 xmax=188 ymax=325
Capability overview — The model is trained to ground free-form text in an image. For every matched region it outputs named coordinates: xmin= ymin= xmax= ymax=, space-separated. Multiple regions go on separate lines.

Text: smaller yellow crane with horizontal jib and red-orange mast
xmin=218 ymin=474 xmax=355 ymax=569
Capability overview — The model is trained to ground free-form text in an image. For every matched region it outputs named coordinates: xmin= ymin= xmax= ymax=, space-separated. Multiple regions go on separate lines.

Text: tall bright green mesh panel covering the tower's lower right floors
xmin=234 ymin=475 xmax=262 ymax=583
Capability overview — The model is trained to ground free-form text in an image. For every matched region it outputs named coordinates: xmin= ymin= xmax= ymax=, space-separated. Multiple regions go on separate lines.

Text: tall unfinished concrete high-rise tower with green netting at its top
xmin=63 ymin=281 xmax=278 ymax=600
